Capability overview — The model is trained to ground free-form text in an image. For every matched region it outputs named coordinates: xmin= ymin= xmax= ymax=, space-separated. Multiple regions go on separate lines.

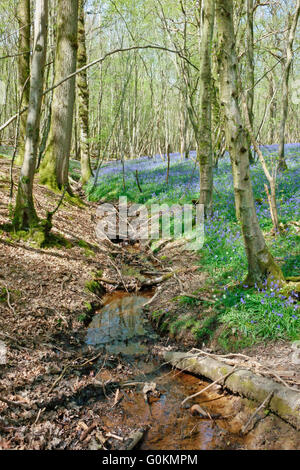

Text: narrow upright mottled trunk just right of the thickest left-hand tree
xmin=77 ymin=0 xmax=92 ymax=184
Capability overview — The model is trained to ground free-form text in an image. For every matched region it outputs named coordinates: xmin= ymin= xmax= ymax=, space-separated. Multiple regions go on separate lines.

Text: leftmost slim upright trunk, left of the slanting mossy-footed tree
xmin=16 ymin=0 xmax=31 ymax=165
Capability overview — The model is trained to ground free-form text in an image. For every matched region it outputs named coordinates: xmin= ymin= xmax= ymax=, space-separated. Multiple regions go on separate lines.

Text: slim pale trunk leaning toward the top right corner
xmin=278 ymin=0 xmax=300 ymax=170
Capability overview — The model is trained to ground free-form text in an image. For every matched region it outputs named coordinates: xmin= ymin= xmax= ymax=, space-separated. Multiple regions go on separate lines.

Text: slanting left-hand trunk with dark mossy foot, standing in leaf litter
xmin=14 ymin=0 xmax=48 ymax=229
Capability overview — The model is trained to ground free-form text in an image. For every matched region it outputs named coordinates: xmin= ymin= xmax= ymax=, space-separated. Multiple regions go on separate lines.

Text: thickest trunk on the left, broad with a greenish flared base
xmin=40 ymin=0 xmax=78 ymax=192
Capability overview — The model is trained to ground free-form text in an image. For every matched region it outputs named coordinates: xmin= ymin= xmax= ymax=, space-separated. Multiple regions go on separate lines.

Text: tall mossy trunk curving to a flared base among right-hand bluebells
xmin=216 ymin=0 xmax=283 ymax=285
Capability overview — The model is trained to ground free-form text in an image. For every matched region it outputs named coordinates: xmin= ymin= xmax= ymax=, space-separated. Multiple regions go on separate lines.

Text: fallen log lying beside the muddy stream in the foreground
xmin=163 ymin=351 xmax=300 ymax=430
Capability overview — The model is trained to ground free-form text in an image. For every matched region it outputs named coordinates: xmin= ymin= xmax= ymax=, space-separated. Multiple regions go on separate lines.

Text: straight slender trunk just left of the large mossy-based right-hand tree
xmin=197 ymin=0 xmax=215 ymax=216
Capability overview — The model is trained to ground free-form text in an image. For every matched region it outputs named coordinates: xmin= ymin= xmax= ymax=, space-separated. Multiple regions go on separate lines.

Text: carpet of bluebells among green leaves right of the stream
xmin=90 ymin=144 xmax=300 ymax=337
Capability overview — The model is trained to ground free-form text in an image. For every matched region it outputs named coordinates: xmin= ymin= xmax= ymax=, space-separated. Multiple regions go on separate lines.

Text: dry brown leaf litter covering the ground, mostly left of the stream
xmin=0 ymin=153 xmax=299 ymax=449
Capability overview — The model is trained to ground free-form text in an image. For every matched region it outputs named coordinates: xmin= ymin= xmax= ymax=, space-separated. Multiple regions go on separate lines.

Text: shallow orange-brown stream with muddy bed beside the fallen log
xmin=86 ymin=292 xmax=296 ymax=450
